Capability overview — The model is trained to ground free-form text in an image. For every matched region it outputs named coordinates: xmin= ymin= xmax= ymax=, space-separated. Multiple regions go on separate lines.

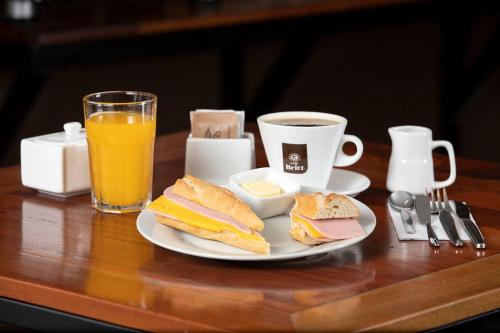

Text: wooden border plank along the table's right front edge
xmin=291 ymin=254 xmax=500 ymax=332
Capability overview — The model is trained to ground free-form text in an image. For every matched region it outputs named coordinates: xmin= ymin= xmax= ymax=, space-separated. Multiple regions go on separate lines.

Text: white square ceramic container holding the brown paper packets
xmin=185 ymin=132 xmax=255 ymax=185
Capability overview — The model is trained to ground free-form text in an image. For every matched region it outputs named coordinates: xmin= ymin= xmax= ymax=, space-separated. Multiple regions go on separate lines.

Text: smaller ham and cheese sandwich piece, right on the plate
xmin=290 ymin=193 xmax=365 ymax=245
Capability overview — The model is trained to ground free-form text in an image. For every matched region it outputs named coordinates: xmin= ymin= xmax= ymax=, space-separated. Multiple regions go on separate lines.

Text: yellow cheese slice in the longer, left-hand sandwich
xmin=148 ymin=195 xmax=262 ymax=239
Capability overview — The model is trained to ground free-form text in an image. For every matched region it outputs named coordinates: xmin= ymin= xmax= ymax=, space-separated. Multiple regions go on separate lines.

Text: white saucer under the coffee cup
xmin=301 ymin=168 xmax=371 ymax=197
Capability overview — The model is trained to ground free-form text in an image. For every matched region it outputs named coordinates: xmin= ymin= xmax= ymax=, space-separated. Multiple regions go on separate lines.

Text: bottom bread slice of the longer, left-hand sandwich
xmin=155 ymin=214 xmax=270 ymax=254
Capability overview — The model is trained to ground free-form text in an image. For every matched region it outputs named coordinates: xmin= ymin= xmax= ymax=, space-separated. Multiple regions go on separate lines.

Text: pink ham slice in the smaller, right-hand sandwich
xmin=297 ymin=214 xmax=365 ymax=240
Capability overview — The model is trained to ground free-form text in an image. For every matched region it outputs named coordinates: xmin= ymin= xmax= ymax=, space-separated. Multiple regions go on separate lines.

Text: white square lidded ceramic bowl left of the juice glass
xmin=21 ymin=122 xmax=90 ymax=197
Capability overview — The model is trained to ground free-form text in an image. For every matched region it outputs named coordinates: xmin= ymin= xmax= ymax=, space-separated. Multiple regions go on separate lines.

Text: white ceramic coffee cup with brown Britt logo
xmin=257 ymin=111 xmax=363 ymax=189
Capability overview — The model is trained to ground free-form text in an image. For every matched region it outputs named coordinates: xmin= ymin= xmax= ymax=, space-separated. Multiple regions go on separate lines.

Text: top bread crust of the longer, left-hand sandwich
xmin=173 ymin=175 xmax=264 ymax=231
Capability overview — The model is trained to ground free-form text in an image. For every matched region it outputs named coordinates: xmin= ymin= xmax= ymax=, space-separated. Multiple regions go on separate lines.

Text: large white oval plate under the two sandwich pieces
xmin=137 ymin=199 xmax=376 ymax=261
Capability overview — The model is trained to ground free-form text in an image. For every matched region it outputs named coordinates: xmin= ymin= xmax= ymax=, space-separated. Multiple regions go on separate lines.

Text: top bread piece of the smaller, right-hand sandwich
xmin=293 ymin=192 xmax=359 ymax=220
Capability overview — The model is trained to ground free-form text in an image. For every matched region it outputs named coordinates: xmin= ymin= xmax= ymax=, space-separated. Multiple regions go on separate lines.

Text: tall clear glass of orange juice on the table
xmin=83 ymin=91 xmax=158 ymax=213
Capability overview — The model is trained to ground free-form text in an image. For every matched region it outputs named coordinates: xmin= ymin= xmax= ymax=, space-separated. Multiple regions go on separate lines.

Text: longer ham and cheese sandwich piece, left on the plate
xmin=148 ymin=175 xmax=269 ymax=254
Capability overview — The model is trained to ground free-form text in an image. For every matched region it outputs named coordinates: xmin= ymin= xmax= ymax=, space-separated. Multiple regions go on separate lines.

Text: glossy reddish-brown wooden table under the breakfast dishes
xmin=0 ymin=129 xmax=500 ymax=332
